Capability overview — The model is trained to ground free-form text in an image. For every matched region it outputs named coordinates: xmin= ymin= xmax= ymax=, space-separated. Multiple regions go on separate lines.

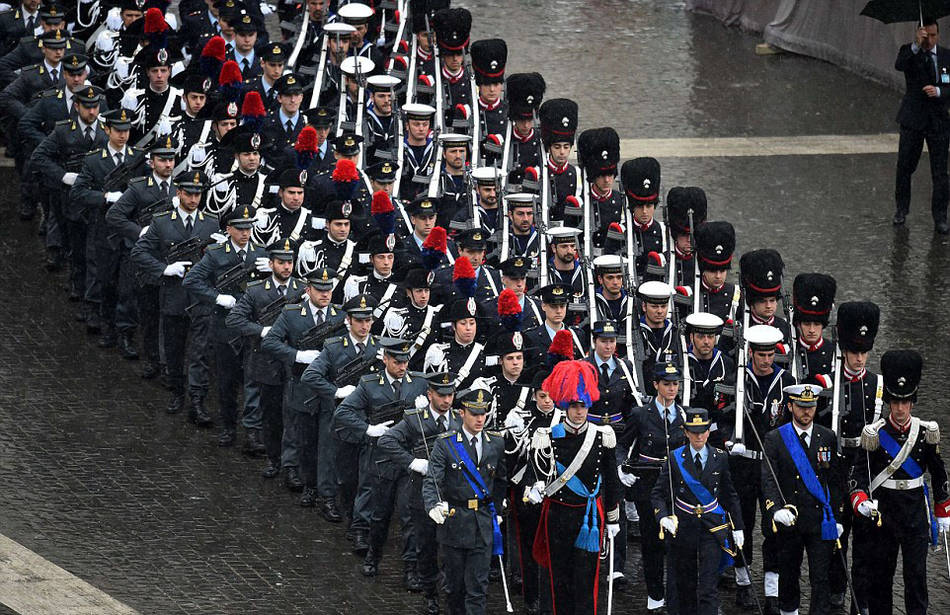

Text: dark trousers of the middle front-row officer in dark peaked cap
xmin=666 ymin=514 xmax=722 ymax=615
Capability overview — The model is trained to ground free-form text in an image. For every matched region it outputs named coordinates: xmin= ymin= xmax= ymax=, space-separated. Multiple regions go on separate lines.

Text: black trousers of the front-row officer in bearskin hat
xmin=872 ymin=512 xmax=930 ymax=615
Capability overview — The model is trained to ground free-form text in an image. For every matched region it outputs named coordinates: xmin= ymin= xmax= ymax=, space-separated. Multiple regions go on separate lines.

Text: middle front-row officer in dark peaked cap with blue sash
xmin=650 ymin=408 xmax=745 ymax=615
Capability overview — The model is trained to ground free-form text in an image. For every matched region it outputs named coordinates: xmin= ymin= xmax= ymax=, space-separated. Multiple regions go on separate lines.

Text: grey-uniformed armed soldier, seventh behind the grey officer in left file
xmin=131 ymin=171 xmax=218 ymax=414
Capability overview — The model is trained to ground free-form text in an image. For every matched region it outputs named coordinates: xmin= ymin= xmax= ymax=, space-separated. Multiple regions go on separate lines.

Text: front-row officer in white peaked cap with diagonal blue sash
xmin=762 ymin=384 xmax=845 ymax=615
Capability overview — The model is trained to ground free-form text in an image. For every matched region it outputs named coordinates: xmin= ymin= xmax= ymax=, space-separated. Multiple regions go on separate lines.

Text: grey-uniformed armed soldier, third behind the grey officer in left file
xmin=300 ymin=295 xmax=384 ymax=556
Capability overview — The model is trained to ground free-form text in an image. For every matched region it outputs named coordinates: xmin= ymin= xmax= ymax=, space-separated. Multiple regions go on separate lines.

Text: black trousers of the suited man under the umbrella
xmin=894 ymin=126 xmax=950 ymax=222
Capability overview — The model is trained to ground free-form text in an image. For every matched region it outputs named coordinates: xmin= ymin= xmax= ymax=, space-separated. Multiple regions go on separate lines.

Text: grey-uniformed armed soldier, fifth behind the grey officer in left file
xmin=224 ymin=239 xmax=304 ymax=478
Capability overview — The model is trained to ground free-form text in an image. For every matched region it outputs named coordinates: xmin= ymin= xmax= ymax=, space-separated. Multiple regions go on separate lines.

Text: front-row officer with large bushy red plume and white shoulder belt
xmin=525 ymin=361 xmax=621 ymax=613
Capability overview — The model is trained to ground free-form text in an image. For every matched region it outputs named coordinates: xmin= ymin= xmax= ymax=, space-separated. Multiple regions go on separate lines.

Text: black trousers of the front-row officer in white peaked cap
xmin=778 ymin=520 xmax=835 ymax=615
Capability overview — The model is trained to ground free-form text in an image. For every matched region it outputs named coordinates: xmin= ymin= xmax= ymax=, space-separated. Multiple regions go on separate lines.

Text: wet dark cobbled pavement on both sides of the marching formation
xmin=0 ymin=0 xmax=950 ymax=614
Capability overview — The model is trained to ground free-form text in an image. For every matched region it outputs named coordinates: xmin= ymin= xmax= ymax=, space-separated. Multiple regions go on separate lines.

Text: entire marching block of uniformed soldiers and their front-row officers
xmin=0 ymin=0 xmax=950 ymax=615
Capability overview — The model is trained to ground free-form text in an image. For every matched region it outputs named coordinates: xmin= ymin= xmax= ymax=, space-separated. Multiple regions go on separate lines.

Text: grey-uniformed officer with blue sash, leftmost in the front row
xmin=422 ymin=389 xmax=507 ymax=615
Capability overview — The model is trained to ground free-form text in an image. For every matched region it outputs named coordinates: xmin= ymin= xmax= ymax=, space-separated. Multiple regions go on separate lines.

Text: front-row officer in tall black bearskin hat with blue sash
xmin=850 ymin=350 xmax=950 ymax=615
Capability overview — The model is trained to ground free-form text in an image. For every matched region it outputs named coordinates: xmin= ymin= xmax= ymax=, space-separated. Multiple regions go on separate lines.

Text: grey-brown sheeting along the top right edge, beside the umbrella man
xmin=686 ymin=0 xmax=932 ymax=89
